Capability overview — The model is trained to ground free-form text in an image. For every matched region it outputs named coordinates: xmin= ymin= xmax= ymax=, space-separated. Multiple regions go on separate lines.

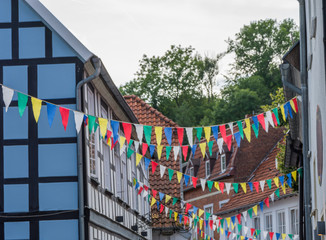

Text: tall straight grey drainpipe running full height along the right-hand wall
xmin=299 ymin=0 xmax=312 ymax=240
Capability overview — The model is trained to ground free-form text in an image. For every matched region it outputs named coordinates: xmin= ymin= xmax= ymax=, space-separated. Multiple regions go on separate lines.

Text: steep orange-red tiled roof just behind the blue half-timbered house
xmin=124 ymin=95 xmax=181 ymax=228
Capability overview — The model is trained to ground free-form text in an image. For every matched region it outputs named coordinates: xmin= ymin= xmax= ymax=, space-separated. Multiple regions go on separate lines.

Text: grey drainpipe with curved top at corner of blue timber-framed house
xmin=76 ymin=57 xmax=102 ymax=240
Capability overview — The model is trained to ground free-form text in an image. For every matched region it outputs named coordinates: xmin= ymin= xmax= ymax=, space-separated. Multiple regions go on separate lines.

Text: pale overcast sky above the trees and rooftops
xmin=41 ymin=0 xmax=299 ymax=87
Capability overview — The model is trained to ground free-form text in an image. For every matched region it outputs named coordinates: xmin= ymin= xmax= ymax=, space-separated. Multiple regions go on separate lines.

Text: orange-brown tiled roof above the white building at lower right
xmin=216 ymin=139 xmax=293 ymax=216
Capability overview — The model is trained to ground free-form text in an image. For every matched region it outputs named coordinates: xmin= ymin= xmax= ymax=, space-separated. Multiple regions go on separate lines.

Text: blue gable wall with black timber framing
xmin=0 ymin=0 xmax=83 ymax=240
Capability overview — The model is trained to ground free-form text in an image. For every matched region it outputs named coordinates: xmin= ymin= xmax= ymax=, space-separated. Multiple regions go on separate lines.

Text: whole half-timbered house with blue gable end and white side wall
xmin=0 ymin=0 xmax=151 ymax=240
